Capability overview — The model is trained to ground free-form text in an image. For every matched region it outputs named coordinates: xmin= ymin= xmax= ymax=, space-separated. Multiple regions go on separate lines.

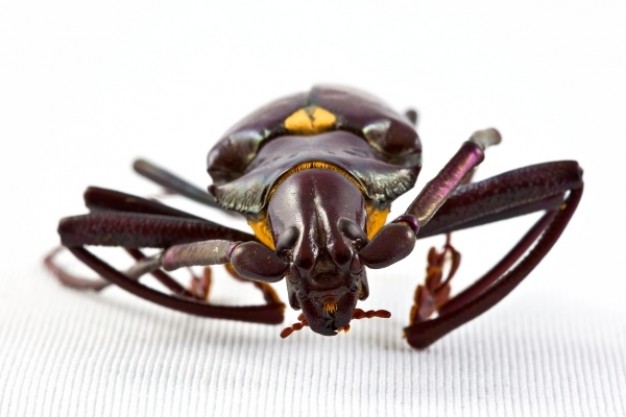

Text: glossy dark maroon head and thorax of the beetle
xmin=268 ymin=168 xmax=368 ymax=335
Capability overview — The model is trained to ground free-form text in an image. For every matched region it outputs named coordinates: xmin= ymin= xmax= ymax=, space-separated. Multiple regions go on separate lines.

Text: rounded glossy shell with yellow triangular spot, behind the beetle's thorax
xmin=208 ymin=86 xmax=421 ymax=215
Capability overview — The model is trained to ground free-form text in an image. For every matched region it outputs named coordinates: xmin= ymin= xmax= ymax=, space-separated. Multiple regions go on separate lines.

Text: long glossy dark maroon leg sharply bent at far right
xmin=405 ymin=161 xmax=583 ymax=349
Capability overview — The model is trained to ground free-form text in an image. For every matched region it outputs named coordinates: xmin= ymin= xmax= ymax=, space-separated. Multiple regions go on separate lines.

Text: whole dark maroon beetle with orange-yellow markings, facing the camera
xmin=45 ymin=86 xmax=583 ymax=349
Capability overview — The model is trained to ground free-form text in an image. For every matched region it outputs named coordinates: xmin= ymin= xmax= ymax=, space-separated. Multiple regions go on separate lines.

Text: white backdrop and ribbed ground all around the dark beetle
xmin=0 ymin=0 xmax=626 ymax=416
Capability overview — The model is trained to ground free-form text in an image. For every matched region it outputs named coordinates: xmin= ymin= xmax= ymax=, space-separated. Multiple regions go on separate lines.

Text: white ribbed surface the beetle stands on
xmin=0 ymin=269 xmax=626 ymax=416
